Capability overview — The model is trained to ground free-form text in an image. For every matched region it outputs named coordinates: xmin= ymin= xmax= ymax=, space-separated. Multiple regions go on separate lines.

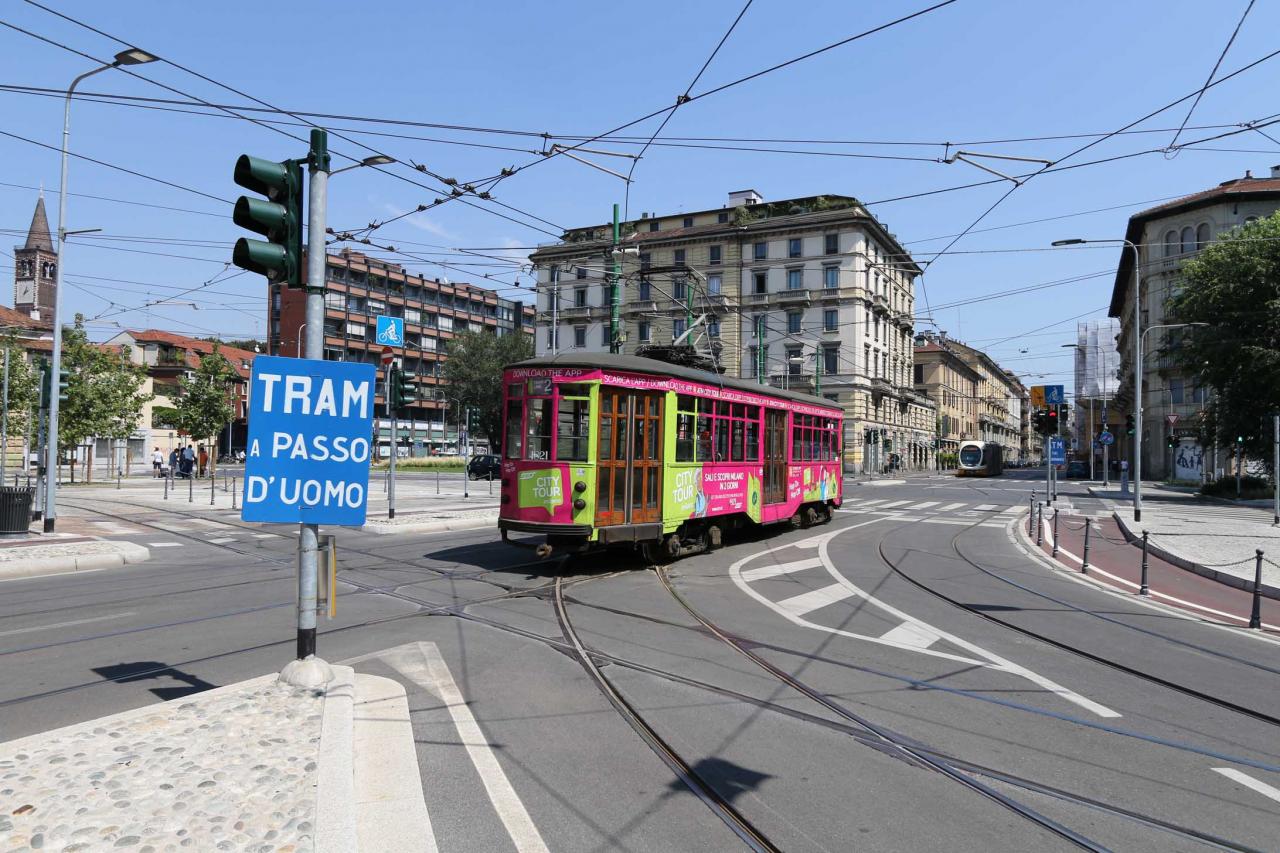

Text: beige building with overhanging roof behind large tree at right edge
xmin=1107 ymin=167 xmax=1280 ymax=482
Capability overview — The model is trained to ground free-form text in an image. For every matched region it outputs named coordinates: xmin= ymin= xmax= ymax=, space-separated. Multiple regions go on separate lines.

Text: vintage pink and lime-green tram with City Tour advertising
xmin=498 ymin=353 xmax=844 ymax=560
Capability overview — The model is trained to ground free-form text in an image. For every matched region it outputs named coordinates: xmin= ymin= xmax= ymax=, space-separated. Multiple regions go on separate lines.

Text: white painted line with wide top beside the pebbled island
xmin=376 ymin=642 xmax=549 ymax=853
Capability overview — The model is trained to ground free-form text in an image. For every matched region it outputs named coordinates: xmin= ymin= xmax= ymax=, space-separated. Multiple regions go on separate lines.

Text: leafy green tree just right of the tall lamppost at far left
xmin=55 ymin=314 xmax=154 ymax=480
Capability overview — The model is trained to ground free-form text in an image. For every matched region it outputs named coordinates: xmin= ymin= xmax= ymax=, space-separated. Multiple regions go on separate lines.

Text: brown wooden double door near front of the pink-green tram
xmin=595 ymin=387 xmax=663 ymax=526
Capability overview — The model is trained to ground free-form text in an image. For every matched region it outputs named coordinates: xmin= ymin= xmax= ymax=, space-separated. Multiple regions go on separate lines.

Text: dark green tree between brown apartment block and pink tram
xmin=443 ymin=326 xmax=534 ymax=440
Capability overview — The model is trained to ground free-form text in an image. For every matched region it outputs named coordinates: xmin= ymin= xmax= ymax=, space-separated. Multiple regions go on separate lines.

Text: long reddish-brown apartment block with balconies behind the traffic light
xmin=268 ymin=248 xmax=534 ymax=456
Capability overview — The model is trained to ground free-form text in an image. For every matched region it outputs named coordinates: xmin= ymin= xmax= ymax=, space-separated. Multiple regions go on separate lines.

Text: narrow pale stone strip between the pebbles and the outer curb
xmin=315 ymin=665 xmax=357 ymax=853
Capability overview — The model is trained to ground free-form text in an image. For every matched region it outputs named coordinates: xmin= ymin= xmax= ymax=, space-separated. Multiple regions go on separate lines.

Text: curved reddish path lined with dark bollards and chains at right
xmin=1015 ymin=505 xmax=1280 ymax=634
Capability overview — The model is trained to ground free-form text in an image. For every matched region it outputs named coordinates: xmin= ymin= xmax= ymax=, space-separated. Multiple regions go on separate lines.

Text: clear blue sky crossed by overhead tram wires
xmin=0 ymin=0 xmax=1280 ymax=382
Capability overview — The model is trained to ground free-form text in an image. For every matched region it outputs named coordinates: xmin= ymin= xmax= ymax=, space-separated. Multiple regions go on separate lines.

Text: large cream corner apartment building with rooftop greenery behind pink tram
xmin=530 ymin=190 xmax=936 ymax=473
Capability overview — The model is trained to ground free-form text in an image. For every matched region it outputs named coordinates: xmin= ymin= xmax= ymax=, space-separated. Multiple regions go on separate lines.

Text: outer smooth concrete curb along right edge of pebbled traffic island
xmin=355 ymin=674 xmax=435 ymax=853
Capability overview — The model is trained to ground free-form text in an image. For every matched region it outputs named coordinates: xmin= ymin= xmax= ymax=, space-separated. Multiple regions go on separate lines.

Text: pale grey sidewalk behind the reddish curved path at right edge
xmin=1089 ymin=484 xmax=1280 ymax=598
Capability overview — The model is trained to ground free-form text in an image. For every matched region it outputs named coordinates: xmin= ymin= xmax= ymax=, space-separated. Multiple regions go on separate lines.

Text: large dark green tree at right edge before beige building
xmin=1165 ymin=213 xmax=1280 ymax=468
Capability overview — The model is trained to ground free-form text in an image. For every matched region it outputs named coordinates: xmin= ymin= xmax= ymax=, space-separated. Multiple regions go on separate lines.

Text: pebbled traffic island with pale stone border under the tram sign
xmin=0 ymin=666 xmax=426 ymax=852
